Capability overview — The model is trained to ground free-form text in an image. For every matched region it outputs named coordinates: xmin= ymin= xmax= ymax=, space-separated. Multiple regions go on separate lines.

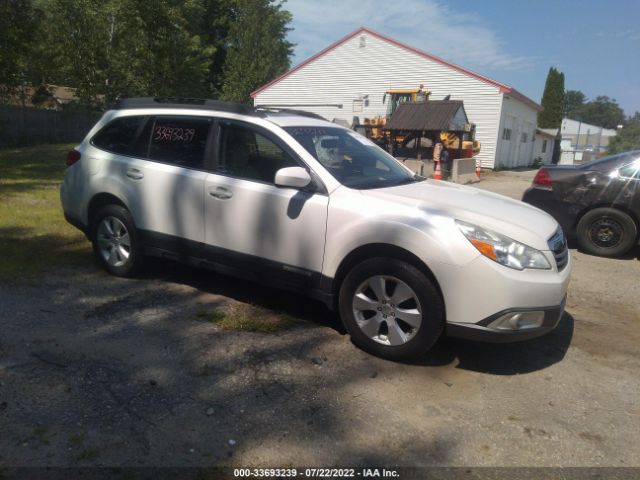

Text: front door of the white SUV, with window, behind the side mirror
xmin=204 ymin=120 xmax=329 ymax=287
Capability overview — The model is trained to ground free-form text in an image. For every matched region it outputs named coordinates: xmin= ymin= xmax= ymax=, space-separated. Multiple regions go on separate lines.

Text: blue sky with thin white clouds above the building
xmin=284 ymin=0 xmax=640 ymax=115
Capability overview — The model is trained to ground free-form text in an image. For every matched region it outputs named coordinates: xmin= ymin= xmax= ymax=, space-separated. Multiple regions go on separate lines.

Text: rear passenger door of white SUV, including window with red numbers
xmin=94 ymin=115 xmax=213 ymax=251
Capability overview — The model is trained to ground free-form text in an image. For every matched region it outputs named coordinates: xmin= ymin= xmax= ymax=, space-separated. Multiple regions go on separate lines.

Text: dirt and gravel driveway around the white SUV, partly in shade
xmin=0 ymin=174 xmax=640 ymax=467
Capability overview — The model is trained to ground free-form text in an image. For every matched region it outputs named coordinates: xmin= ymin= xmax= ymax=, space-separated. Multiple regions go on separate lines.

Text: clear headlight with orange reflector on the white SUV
xmin=456 ymin=220 xmax=551 ymax=270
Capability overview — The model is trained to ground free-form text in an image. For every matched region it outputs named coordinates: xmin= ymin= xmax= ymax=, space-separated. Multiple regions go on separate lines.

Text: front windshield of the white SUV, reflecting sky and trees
xmin=285 ymin=127 xmax=424 ymax=189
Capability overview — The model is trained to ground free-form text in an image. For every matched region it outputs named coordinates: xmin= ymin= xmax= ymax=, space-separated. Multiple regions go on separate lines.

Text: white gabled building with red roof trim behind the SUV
xmin=251 ymin=28 xmax=540 ymax=168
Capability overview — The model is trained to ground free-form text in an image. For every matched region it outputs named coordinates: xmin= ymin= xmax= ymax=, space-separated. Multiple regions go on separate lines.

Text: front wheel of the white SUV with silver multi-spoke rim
xmin=339 ymin=258 xmax=444 ymax=360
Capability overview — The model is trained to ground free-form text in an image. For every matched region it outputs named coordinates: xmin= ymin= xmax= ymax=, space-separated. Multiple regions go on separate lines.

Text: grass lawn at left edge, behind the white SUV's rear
xmin=0 ymin=145 xmax=90 ymax=283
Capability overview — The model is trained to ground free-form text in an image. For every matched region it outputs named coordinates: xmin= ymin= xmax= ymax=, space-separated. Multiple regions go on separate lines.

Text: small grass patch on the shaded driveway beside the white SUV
xmin=197 ymin=303 xmax=292 ymax=333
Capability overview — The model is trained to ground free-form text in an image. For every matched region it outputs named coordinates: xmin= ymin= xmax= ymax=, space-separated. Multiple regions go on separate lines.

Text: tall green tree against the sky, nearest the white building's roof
xmin=222 ymin=0 xmax=293 ymax=102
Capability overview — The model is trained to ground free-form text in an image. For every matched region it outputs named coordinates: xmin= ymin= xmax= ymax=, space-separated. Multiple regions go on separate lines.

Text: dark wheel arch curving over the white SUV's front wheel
xmin=329 ymin=243 xmax=446 ymax=312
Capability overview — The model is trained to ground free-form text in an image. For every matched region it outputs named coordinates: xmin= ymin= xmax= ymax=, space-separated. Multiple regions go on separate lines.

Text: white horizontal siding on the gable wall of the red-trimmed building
xmin=254 ymin=32 xmax=510 ymax=168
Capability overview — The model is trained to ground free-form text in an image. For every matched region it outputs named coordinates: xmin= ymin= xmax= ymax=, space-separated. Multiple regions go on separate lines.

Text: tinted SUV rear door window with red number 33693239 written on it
xmin=149 ymin=117 xmax=211 ymax=169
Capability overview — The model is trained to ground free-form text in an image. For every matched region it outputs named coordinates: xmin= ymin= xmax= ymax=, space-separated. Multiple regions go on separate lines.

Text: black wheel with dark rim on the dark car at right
xmin=576 ymin=208 xmax=637 ymax=257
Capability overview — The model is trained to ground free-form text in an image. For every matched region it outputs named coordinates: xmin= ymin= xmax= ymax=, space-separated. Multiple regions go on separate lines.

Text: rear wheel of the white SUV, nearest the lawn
xmin=91 ymin=205 xmax=141 ymax=277
